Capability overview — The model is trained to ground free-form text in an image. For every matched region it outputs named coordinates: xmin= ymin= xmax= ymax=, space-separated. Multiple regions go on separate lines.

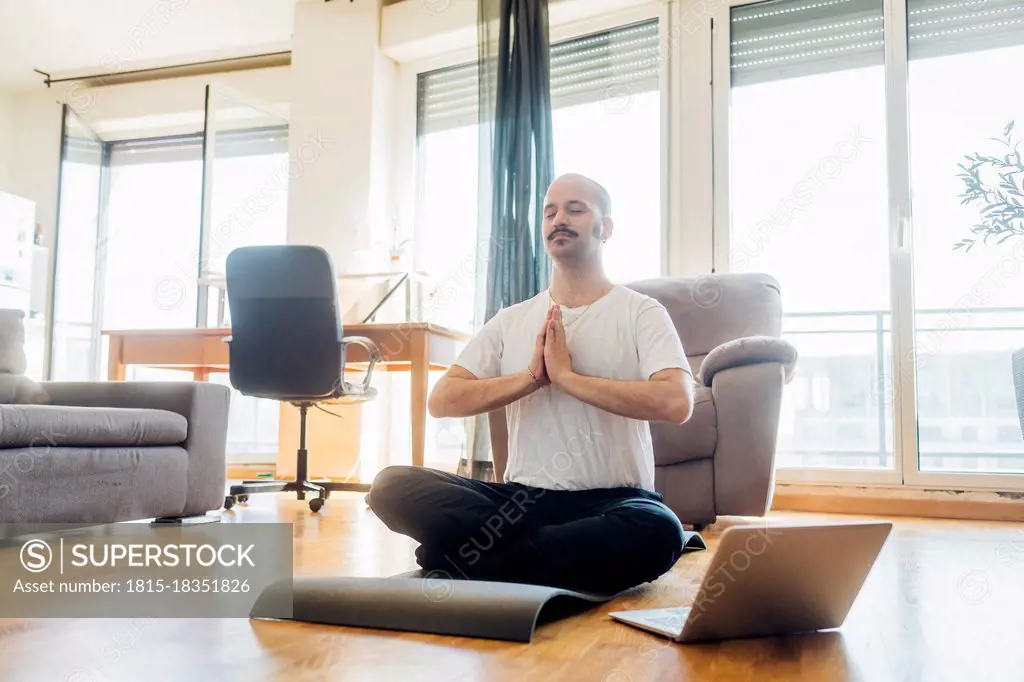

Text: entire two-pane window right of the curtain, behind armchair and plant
xmin=716 ymin=0 xmax=1024 ymax=486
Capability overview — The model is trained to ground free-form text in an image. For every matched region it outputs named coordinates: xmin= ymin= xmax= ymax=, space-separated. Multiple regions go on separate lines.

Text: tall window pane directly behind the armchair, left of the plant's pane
xmin=729 ymin=0 xmax=894 ymax=468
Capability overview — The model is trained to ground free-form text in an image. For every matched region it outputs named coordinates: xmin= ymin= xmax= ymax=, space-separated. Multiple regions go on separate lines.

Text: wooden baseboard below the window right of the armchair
xmin=771 ymin=484 xmax=1024 ymax=522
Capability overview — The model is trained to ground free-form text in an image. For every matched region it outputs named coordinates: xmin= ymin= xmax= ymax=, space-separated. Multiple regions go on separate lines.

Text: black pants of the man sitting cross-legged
xmin=367 ymin=466 xmax=684 ymax=593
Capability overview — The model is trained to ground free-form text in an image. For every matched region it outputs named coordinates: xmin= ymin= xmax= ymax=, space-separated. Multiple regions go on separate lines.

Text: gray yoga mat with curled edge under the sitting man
xmin=250 ymin=532 xmax=707 ymax=642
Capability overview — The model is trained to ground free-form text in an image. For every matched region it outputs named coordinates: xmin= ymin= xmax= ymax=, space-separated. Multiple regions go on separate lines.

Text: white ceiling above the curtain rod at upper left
xmin=0 ymin=0 xmax=302 ymax=91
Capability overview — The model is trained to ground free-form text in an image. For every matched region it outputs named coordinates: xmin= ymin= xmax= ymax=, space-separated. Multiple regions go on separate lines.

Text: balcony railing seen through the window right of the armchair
xmin=779 ymin=307 xmax=1024 ymax=472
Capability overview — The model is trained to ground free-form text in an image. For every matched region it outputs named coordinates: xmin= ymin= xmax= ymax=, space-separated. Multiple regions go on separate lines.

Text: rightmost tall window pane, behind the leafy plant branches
xmin=908 ymin=0 xmax=1024 ymax=473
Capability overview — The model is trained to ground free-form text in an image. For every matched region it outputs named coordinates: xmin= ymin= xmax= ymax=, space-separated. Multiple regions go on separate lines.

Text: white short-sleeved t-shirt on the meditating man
xmin=456 ymin=286 xmax=690 ymax=491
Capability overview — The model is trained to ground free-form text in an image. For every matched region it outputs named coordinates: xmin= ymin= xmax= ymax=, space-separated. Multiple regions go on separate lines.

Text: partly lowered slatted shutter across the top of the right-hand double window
xmin=730 ymin=0 xmax=1024 ymax=86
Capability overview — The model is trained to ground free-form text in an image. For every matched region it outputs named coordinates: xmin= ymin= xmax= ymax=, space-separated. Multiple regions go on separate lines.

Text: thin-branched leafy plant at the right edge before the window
xmin=953 ymin=121 xmax=1024 ymax=436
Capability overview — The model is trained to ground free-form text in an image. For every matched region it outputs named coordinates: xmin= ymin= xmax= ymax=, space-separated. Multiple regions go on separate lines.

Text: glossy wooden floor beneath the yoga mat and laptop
xmin=0 ymin=494 xmax=1024 ymax=682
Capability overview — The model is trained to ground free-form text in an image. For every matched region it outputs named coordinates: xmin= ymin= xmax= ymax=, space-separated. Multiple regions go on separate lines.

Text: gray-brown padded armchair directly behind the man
xmin=628 ymin=273 xmax=797 ymax=525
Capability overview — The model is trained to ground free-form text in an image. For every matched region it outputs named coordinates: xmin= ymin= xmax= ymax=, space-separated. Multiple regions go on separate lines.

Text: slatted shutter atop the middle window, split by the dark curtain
xmin=417 ymin=19 xmax=660 ymax=135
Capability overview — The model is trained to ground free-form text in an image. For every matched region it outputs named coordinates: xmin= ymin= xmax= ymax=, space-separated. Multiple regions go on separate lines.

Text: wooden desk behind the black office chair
xmin=103 ymin=323 xmax=470 ymax=466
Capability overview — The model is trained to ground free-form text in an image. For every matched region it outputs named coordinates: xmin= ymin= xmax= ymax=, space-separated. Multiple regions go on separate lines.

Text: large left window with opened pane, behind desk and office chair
xmin=51 ymin=112 xmax=288 ymax=463
